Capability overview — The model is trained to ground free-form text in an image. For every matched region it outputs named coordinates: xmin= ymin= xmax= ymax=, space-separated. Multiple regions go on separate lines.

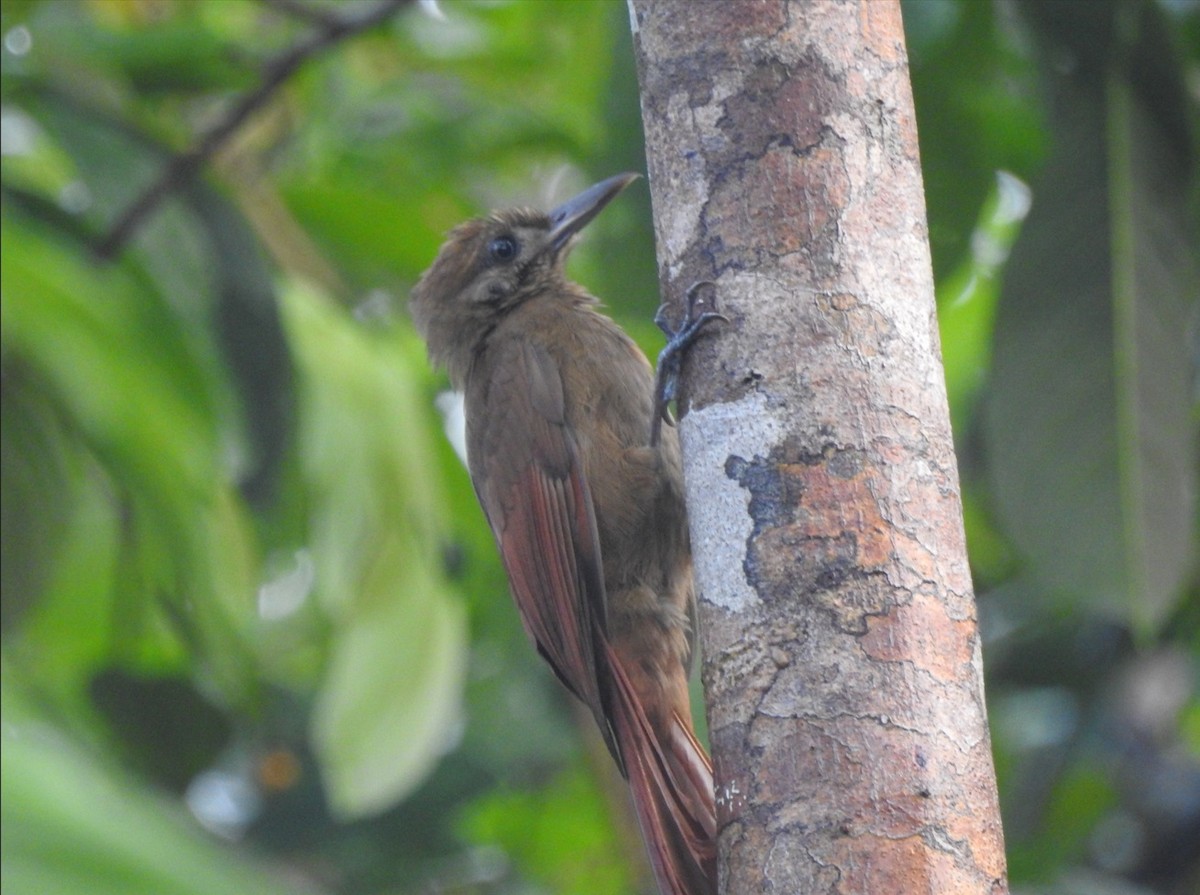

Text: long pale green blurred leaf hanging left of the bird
xmin=287 ymin=278 xmax=467 ymax=817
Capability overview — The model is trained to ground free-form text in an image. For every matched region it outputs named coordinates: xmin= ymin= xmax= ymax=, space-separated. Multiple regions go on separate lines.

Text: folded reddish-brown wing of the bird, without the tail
xmin=467 ymin=340 xmax=622 ymax=763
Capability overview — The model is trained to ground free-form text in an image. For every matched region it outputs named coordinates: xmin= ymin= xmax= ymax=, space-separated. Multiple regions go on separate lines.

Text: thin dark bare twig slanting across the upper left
xmin=96 ymin=0 xmax=413 ymax=260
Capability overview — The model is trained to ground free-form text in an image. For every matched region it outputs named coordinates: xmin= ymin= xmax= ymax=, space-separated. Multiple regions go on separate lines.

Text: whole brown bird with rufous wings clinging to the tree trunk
xmin=410 ymin=174 xmax=716 ymax=895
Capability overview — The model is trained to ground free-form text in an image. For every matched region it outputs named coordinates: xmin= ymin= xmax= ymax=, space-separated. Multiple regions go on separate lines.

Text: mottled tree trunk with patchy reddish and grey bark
xmin=630 ymin=0 xmax=1007 ymax=895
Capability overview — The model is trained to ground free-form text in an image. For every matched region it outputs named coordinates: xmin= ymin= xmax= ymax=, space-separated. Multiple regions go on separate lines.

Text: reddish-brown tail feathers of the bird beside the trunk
xmin=608 ymin=647 xmax=716 ymax=895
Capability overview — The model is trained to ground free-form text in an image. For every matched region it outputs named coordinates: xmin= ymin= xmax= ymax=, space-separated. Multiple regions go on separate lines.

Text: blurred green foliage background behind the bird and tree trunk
xmin=0 ymin=0 xmax=1200 ymax=895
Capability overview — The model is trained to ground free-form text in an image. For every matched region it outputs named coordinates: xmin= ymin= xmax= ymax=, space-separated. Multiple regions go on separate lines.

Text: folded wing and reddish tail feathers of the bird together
xmin=467 ymin=341 xmax=716 ymax=895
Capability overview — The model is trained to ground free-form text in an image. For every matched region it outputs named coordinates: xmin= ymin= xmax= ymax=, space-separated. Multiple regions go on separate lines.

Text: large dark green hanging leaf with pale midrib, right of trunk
xmin=986 ymin=4 xmax=1200 ymax=630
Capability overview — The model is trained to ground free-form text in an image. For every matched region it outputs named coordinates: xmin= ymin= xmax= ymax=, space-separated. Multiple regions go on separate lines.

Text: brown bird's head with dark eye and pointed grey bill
xmin=409 ymin=174 xmax=638 ymax=382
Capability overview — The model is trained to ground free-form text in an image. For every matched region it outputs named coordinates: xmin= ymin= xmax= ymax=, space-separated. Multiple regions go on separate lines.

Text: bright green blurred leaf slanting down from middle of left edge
xmin=0 ymin=215 xmax=217 ymax=537
